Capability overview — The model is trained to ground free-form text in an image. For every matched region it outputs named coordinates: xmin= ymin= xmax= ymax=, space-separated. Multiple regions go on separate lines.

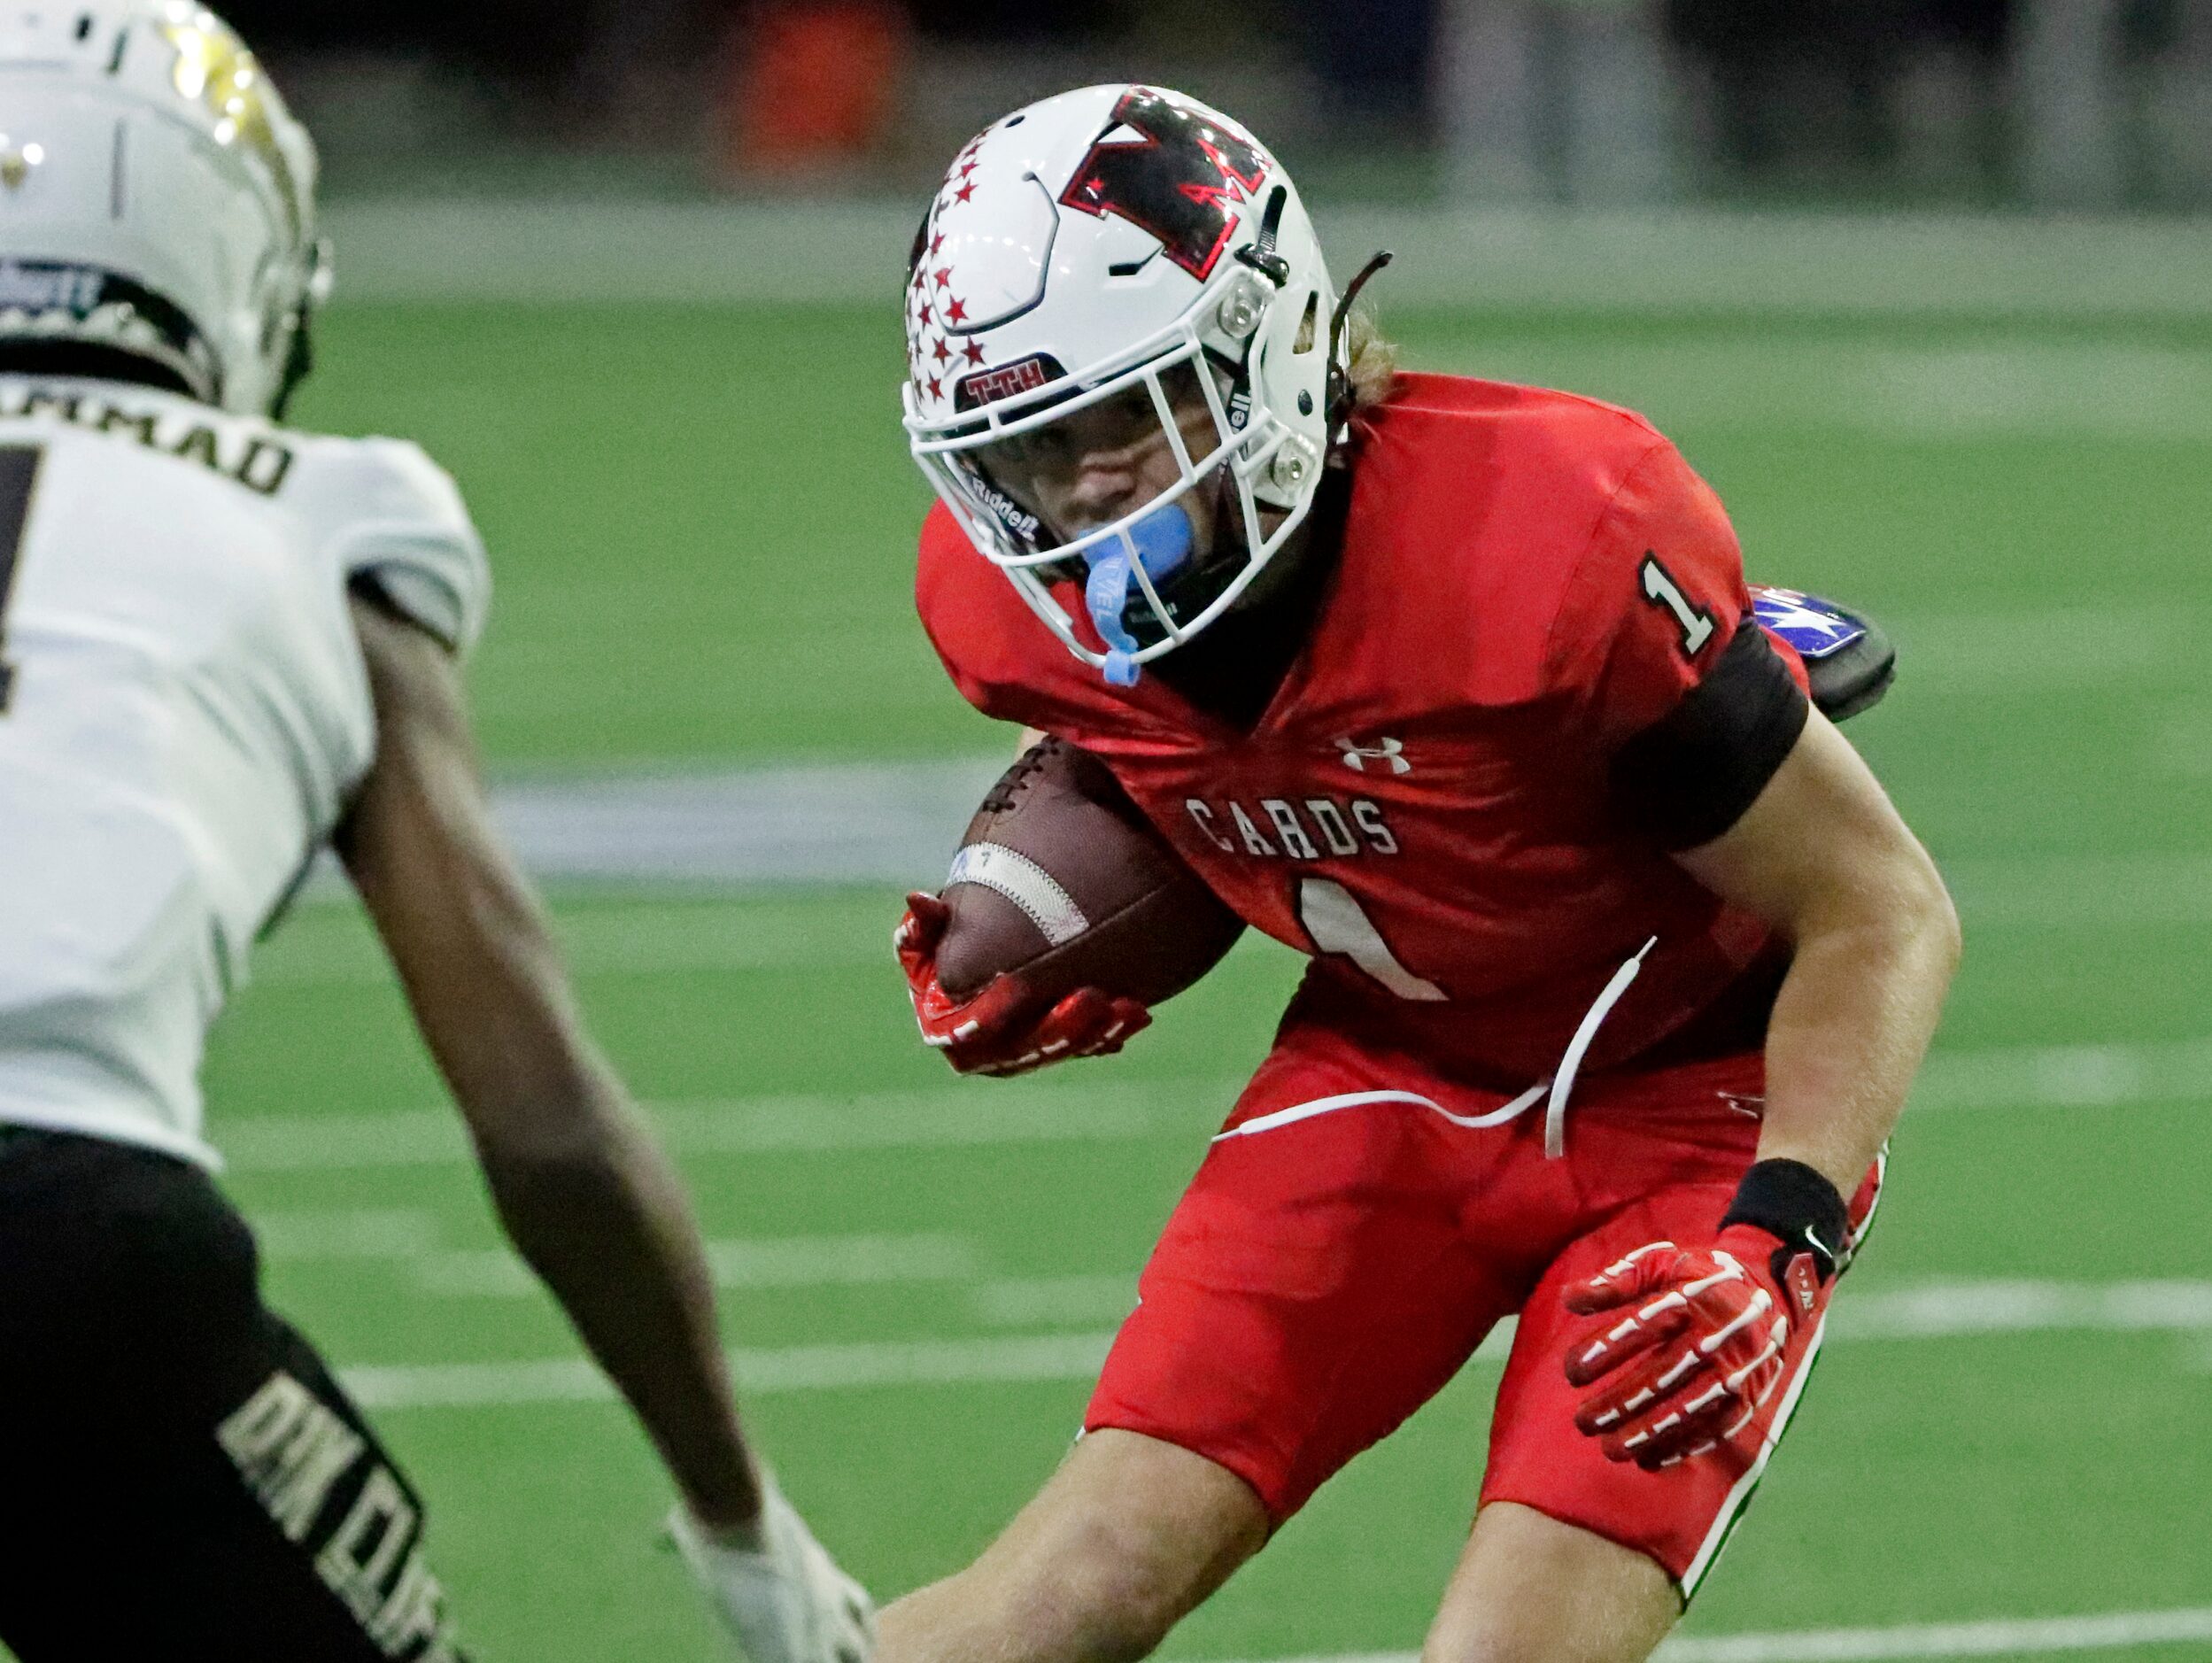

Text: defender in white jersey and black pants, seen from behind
xmin=0 ymin=0 xmax=871 ymax=1663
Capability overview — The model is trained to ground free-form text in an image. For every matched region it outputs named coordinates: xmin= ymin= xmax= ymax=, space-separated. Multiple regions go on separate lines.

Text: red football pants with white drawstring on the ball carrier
xmin=1084 ymin=1028 xmax=1878 ymax=1599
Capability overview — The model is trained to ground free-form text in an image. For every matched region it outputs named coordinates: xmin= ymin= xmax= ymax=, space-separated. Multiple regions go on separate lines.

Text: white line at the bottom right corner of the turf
xmin=1203 ymin=1605 xmax=2212 ymax=1663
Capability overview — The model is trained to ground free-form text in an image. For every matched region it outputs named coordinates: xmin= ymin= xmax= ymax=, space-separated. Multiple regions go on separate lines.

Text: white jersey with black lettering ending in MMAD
xmin=0 ymin=376 xmax=489 ymax=1165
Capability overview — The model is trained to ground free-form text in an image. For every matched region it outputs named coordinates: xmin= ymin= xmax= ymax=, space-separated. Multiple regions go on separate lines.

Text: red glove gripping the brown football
xmin=892 ymin=893 xmax=1152 ymax=1075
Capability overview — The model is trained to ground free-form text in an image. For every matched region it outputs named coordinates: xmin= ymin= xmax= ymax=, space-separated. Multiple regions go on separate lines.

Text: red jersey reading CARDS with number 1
xmin=918 ymin=374 xmax=1778 ymax=1090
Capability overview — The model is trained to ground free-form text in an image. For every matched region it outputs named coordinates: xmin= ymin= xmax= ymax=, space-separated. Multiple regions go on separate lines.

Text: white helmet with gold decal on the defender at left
xmin=0 ymin=0 xmax=329 ymax=416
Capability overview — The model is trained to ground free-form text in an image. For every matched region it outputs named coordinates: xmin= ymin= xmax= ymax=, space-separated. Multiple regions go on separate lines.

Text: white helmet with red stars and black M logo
xmin=905 ymin=86 xmax=1341 ymax=684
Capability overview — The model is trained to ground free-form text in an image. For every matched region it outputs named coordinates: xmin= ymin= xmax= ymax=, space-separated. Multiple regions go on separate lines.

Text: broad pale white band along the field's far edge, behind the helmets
xmin=325 ymin=192 xmax=2212 ymax=316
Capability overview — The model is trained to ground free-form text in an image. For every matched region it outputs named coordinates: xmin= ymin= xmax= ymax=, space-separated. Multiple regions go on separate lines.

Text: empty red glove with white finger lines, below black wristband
xmin=1566 ymin=1223 xmax=1827 ymax=1471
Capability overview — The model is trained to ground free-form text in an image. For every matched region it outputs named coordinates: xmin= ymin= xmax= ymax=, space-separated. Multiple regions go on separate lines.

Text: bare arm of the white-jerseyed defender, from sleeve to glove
xmin=336 ymin=599 xmax=761 ymax=1530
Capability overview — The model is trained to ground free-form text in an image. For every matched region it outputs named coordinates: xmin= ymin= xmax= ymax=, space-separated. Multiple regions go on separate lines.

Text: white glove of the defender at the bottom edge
xmin=668 ymin=1484 xmax=876 ymax=1663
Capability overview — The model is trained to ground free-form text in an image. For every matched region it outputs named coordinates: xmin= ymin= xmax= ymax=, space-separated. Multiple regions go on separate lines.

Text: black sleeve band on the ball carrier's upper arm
xmin=1613 ymin=617 xmax=1812 ymax=849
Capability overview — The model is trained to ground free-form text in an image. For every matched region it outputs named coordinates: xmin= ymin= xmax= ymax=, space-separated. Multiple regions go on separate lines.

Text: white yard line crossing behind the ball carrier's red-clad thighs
xmin=345 ymin=1276 xmax=2212 ymax=1409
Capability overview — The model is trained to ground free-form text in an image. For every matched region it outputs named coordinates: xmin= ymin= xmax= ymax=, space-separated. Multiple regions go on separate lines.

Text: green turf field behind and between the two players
xmin=185 ymin=307 xmax=2212 ymax=1663
